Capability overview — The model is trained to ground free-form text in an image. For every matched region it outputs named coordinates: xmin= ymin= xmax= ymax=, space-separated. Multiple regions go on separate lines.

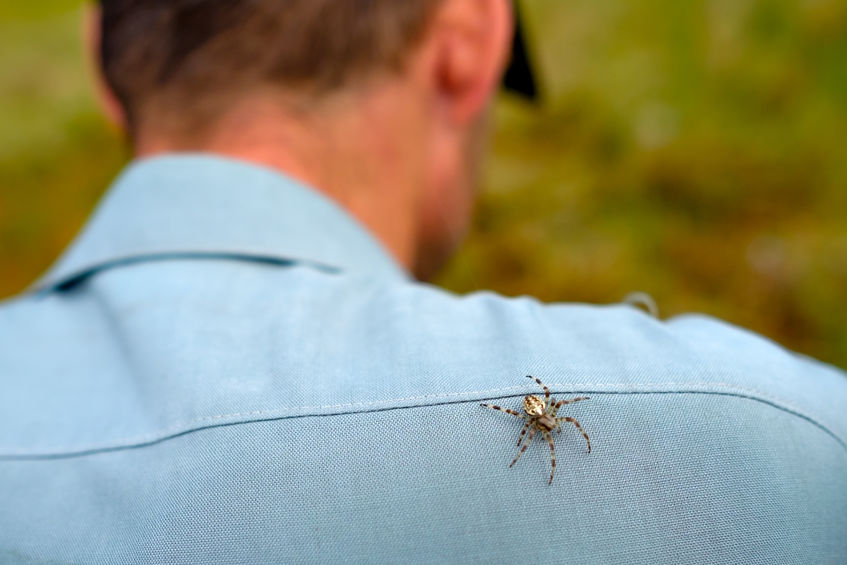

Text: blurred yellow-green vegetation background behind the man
xmin=0 ymin=0 xmax=847 ymax=367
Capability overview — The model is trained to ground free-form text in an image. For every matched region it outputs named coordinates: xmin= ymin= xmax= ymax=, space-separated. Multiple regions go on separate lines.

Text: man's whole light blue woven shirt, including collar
xmin=0 ymin=154 xmax=847 ymax=564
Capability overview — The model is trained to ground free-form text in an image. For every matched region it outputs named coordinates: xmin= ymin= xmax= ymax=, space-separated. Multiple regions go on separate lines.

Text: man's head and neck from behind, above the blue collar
xmin=93 ymin=0 xmax=511 ymax=276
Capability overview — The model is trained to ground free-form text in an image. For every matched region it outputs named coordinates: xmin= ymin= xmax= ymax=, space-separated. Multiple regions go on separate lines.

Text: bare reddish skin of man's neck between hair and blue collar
xmin=136 ymin=92 xmax=428 ymax=278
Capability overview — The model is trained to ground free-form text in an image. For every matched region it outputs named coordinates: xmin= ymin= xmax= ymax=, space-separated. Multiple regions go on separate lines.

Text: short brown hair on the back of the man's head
xmin=100 ymin=0 xmax=440 ymax=137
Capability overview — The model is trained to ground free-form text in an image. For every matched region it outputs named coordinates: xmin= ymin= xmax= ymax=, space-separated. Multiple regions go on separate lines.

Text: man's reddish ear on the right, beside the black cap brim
xmin=427 ymin=0 xmax=514 ymax=124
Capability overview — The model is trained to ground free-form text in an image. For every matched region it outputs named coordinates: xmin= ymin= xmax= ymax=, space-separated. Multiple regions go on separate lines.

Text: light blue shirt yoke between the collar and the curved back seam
xmin=0 ymin=260 xmax=847 ymax=458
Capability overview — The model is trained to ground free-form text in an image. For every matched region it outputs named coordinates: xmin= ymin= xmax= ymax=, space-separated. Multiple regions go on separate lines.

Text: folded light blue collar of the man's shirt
xmin=34 ymin=154 xmax=407 ymax=290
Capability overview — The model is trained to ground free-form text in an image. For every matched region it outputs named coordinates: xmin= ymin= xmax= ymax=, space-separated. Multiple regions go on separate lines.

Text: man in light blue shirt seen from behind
xmin=0 ymin=0 xmax=847 ymax=563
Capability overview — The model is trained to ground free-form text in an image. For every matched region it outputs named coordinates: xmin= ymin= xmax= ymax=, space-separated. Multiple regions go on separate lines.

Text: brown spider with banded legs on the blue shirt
xmin=480 ymin=375 xmax=591 ymax=485
